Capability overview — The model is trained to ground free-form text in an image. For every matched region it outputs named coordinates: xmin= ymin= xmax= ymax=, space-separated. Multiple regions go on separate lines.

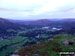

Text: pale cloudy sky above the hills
xmin=0 ymin=0 xmax=75 ymax=20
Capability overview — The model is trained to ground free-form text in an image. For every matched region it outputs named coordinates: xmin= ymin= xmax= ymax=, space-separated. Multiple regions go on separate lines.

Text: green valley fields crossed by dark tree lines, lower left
xmin=0 ymin=37 xmax=28 ymax=56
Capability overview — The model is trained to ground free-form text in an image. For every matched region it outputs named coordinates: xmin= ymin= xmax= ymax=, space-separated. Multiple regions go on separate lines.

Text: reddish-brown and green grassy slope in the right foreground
xmin=16 ymin=34 xmax=75 ymax=56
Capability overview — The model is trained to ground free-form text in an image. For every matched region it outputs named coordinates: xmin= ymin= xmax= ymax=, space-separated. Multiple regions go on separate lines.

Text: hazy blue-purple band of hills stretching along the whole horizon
xmin=0 ymin=18 xmax=75 ymax=31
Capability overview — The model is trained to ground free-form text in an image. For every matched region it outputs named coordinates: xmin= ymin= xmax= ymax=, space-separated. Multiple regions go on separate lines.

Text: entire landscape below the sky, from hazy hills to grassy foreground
xmin=0 ymin=18 xmax=75 ymax=56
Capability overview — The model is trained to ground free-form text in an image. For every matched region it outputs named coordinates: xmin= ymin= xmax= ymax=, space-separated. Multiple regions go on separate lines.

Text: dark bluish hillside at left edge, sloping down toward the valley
xmin=0 ymin=18 xmax=24 ymax=36
